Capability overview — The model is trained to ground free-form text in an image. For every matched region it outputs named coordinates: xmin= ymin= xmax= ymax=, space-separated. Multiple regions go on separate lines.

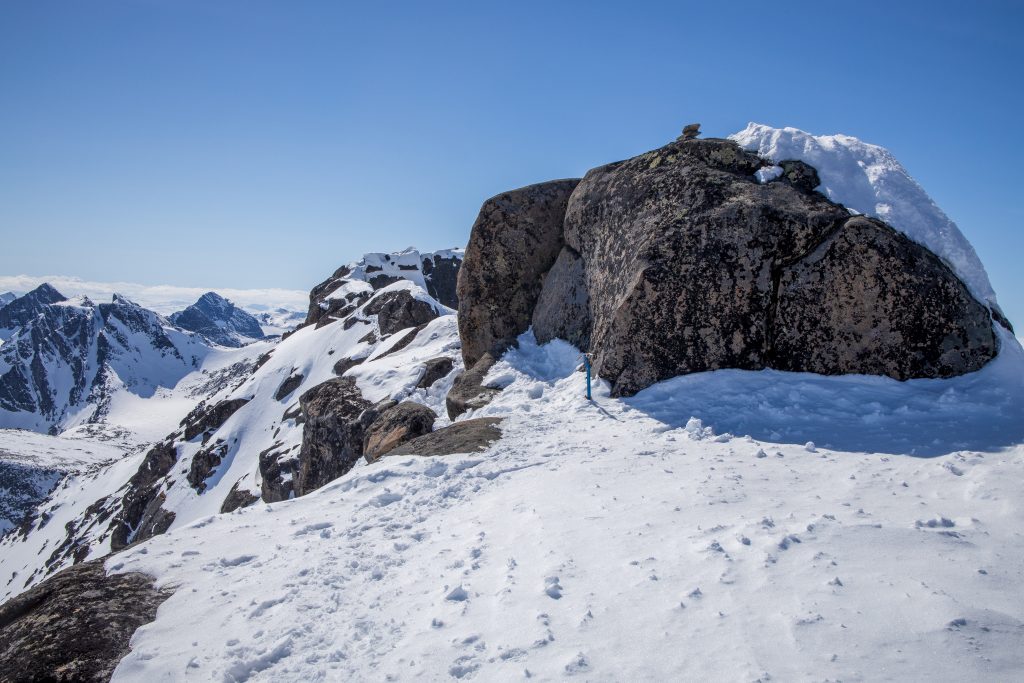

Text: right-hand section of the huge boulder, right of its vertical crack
xmin=768 ymin=217 xmax=996 ymax=380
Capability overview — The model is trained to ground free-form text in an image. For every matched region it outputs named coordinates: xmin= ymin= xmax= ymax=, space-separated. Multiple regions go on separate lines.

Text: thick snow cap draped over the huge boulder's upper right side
xmin=729 ymin=123 xmax=996 ymax=306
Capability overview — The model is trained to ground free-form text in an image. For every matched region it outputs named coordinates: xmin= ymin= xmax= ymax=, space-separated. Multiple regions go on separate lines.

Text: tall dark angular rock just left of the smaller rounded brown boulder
xmin=294 ymin=377 xmax=377 ymax=496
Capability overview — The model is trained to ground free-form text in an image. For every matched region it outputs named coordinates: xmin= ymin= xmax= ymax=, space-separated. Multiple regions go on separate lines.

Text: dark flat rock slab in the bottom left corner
xmin=0 ymin=560 xmax=170 ymax=682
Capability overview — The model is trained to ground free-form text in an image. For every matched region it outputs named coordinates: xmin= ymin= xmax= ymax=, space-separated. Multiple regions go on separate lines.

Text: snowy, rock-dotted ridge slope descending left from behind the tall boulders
xmin=0 ymin=250 xmax=461 ymax=601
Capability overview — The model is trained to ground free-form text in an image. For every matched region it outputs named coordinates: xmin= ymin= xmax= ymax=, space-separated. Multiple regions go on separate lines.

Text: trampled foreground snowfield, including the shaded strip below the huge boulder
xmin=108 ymin=329 xmax=1024 ymax=681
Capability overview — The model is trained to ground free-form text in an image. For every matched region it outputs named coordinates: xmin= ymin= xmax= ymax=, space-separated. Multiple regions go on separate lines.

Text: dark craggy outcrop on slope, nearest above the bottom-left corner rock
xmin=111 ymin=440 xmax=178 ymax=551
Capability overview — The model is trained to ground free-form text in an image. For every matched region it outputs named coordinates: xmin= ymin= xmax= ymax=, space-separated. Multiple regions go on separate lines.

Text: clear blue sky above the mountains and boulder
xmin=0 ymin=0 xmax=1024 ymax=327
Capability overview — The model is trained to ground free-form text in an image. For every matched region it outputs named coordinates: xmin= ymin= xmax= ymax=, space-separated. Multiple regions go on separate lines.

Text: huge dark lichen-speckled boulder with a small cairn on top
xmin=516 ymin=139 xmax=996 ymax=395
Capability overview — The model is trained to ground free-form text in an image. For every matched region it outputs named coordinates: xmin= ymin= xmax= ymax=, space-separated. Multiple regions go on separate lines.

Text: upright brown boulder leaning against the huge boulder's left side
xmin=457 ymin=179 xmax=580 ymax=368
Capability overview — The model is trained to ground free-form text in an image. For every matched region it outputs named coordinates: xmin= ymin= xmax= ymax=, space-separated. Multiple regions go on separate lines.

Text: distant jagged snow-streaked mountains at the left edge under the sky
xmin=0 ymin=284 xmax=284 ymax=433
